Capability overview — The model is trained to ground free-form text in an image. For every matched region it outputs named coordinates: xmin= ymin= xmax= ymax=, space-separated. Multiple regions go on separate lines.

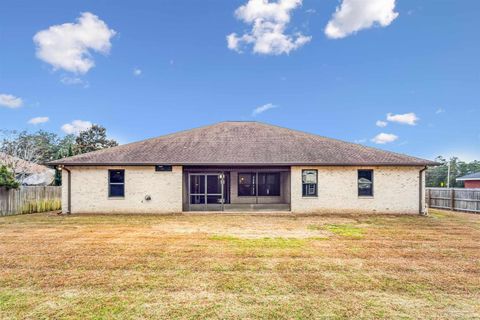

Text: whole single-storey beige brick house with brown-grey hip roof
xmin=51 ymin=121 xmax=436 ymax=213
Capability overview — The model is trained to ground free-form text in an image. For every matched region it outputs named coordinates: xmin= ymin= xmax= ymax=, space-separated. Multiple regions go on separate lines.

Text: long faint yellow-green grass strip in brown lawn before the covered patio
xmin=209 ymin=235 xmax=307 ymax=249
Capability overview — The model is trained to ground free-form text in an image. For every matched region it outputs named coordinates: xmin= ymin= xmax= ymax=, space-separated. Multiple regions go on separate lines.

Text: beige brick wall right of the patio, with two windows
xmin=291 ymin=166 xmax=424 ymax=213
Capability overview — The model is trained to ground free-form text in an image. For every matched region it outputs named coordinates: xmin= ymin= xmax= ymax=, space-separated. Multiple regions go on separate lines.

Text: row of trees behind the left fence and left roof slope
xmin=0 ymin=125 xmax=118 ymax=188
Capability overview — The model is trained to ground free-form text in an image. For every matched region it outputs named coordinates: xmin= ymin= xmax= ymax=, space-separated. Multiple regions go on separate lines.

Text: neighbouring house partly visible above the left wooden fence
xmin=0 ymin=152 xmax=55 ymax=186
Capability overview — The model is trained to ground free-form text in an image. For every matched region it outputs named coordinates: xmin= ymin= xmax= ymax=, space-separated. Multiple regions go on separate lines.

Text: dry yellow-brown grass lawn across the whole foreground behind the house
xmin=0 ymin=210 xmax=480 ymax=319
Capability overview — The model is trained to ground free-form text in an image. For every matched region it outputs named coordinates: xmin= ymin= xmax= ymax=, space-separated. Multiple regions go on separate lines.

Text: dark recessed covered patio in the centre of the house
xmin=183 ymin=166 xmax=290 ymax=212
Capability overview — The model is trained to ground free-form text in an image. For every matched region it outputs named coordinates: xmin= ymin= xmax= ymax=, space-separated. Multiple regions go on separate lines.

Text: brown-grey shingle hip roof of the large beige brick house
xmin=50 ymin=121 xmax=436 ymax=166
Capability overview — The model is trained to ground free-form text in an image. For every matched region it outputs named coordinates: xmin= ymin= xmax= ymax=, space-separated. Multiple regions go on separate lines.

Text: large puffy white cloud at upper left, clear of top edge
xmin=33 ymin=12 xmax=116 ymax=74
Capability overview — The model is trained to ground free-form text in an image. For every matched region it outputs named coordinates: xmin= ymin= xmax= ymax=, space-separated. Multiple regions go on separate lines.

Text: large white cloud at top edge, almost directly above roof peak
xmin=227 ymin=0 xmax=312 ymax=55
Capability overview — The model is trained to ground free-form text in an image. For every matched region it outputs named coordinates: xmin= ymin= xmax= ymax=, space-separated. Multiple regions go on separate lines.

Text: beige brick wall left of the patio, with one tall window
xmin=62 ymin=166 xmax=182 ymax=213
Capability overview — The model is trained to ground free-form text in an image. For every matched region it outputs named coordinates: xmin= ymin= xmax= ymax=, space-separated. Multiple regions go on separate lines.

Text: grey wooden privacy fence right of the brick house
xmin=426 ymin=188 xmax=480 ymax=213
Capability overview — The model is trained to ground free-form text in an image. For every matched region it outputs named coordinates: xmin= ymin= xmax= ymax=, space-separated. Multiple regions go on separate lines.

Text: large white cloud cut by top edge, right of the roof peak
xmin=325 ymin=0 xmax=398 ymax=39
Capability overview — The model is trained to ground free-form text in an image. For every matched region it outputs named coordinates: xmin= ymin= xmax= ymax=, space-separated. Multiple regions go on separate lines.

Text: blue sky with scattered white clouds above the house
xmin=0 ymin=0 xmax=480 ymax=161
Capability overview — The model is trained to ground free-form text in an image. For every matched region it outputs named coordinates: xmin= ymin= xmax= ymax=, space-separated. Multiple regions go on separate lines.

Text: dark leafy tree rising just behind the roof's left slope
xmin=75 ymin=124 xmax=118 ymax=154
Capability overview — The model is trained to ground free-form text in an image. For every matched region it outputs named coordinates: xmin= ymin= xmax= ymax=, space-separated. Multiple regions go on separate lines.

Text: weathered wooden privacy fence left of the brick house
xmin=0 ymin=186 xmax=62 ymax=216
